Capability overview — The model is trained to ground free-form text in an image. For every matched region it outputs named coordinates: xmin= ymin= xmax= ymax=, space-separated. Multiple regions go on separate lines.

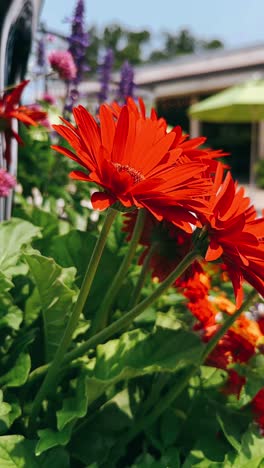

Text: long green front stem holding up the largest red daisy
xmin=29 ymin=209 xmax=117 ymax=433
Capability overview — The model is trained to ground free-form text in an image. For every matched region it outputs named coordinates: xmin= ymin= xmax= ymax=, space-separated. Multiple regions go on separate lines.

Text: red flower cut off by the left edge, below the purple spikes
xmin=0 ymin=81 xmax=47 ymax=168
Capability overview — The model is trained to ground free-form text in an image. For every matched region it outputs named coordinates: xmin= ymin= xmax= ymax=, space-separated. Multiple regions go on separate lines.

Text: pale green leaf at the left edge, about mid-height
xmin=0 ymin=218 xmax=40 ymax=277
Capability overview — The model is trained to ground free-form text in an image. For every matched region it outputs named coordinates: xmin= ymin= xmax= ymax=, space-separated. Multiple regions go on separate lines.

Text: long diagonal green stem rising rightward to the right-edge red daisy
xmin=63 ymin=250 xmax=201 ymax=364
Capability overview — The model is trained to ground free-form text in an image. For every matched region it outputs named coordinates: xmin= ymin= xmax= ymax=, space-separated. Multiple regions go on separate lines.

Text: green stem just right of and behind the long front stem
xmin=91 ymin=209 xmax=146 ymax=334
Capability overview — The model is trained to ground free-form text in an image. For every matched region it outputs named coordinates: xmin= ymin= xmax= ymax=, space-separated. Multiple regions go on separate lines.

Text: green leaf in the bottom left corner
xmin=0 ymin=435 xmax=39 ymax=468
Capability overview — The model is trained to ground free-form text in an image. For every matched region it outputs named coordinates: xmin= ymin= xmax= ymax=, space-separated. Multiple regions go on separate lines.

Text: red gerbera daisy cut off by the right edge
xmin=201 ymin=167 xmax=264 ymax=307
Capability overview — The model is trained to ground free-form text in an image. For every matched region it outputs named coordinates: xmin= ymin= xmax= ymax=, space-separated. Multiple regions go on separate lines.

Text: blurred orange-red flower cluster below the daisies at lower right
xmin=182 ymin=273 xmax=264 ymax=432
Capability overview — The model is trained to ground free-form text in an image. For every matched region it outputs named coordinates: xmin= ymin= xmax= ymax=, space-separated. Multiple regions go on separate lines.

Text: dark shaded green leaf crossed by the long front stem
xmin=46 ymin=230 xmax=122 ymax=315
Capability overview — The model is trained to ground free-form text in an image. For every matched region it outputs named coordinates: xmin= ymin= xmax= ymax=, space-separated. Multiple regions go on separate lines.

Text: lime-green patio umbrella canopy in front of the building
xmin=189 ymin=80 xmax=264 ymax=123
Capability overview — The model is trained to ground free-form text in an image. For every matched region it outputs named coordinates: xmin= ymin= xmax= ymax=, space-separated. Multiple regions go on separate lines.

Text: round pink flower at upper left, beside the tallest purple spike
xmin=48 ymin=50 xmax=77 ymax=81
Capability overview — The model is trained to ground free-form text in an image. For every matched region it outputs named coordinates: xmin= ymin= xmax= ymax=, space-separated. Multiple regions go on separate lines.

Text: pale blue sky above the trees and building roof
xmin=41 ymin=0 xmax=264 ymax=47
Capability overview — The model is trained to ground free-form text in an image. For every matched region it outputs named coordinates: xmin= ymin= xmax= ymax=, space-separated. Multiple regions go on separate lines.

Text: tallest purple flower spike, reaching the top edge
xmin=68 ymin=0 xmax=89 ymax=85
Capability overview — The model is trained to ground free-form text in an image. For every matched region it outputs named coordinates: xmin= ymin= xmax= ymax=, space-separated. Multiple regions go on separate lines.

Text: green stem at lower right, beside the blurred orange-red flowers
xmin=202 ymin=289 xmax=258 ymax=362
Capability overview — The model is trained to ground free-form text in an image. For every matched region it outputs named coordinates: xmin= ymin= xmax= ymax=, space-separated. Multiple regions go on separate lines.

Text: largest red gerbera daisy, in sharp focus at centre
xmin=53 ymin=99 xmax=212 ymax=229
